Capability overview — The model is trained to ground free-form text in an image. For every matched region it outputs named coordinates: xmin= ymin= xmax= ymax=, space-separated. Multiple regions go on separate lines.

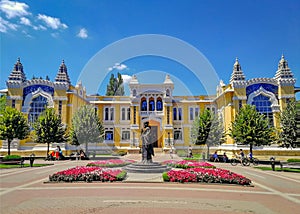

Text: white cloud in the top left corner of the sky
xmin=0 ymin=0 xmax=30 ymax=19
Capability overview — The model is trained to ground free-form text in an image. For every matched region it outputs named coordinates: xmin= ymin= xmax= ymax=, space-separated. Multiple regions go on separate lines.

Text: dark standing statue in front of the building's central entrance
xmin=141 ymin=122 xmax=154 ymax=163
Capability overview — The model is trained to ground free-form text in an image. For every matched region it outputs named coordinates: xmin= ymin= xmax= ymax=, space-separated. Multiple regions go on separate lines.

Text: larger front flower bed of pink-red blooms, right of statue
xmin=163 ymin=168 xmax=251 ymax=185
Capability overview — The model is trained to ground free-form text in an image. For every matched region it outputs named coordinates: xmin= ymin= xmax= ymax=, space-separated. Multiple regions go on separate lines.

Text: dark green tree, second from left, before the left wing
xmin=33 ymin=108 xmax=67 ymax=155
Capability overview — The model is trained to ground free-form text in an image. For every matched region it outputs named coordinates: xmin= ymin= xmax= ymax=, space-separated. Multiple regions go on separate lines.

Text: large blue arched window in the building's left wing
xmin=28 ymin=96 xmax=48 ymax=123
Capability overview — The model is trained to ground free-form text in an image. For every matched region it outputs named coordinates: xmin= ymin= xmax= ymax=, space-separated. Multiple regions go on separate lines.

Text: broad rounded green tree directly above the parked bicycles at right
xmin=229 ymin=105 xmax=274 ymax=153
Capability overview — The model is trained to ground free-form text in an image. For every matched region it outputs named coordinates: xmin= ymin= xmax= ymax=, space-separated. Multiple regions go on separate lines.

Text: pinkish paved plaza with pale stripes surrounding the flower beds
xmin=0 ymin=154 xmax=300 ymax=214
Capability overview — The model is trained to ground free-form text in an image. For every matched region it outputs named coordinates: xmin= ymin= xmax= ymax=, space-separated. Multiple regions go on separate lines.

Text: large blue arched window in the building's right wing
xmin=251 ymin=94 xmax=274 ymax=126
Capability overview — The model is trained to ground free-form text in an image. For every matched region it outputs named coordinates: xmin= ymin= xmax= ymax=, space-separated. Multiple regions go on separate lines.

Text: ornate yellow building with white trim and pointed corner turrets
xmin=1 ymin=56 xmax=296 ymax=155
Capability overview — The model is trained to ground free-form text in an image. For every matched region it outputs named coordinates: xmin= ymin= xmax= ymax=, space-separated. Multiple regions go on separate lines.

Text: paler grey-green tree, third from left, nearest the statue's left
xmin=70 ymin=105 xmax=104 ymax=152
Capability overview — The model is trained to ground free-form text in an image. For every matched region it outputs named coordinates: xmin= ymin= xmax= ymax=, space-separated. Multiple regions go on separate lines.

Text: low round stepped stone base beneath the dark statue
xmin=123 ymin=162 xmax=171 ymax=173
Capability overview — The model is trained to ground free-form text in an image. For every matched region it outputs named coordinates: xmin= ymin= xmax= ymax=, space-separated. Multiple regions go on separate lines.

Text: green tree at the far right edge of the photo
xmin=280 ymin=101 xmax=297 ymax=147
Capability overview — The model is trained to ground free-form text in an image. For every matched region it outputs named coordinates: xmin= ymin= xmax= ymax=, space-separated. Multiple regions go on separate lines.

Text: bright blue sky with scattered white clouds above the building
xmin=0 ymin=0 xmax=300 ymax=100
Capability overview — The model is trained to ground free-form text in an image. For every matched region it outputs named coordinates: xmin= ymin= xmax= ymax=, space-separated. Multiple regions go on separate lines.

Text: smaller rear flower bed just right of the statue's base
xmin=163 ymin=160 xmax=216 ymax=169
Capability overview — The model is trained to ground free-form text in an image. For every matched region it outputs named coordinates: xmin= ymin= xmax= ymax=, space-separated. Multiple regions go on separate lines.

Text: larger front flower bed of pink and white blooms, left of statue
xmin=49 ymin=166 xmax=126 ymax=182
